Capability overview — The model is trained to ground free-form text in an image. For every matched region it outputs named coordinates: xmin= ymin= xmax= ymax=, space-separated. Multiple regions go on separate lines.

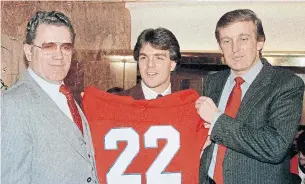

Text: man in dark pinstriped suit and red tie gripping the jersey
xmin=195 ymin=9 xmax=304 ymax=184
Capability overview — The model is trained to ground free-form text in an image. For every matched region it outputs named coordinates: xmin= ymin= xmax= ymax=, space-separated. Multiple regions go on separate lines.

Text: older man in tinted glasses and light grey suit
xmin=1 ymin=11 xmax=98 ymax=184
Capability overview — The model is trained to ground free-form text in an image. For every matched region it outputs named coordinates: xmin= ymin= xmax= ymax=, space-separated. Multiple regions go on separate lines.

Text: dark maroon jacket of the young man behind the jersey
xmin=117 ymin=82 xmax=179 ymax=100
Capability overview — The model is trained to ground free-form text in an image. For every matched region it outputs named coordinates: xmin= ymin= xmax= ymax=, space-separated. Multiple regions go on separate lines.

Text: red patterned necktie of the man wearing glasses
xmin=59 ymin=84 xmax=83 ymax=134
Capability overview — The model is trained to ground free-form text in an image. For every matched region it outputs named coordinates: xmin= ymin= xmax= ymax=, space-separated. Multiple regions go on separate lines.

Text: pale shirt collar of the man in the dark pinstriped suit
xmin=229 ymin=60 xmax=264 ymax=85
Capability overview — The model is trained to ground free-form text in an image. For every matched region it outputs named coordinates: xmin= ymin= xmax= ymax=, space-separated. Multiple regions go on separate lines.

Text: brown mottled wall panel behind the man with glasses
xmin=1 ymin=1 xmax=136 ymax=98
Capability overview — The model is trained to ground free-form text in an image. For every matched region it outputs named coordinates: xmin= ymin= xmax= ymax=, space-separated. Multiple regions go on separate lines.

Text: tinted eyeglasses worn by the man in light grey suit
xmin=33 ymin=42 xmax=74 ymax=55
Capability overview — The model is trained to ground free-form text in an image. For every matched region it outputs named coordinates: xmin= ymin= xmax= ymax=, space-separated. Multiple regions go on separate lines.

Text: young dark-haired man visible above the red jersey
xmin=119 ymin=28 xmax=181 ymax=100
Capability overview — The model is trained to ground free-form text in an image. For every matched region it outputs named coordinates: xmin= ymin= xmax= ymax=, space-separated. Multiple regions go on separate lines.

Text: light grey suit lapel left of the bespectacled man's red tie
xmin=22 ymin=72 xmax=90 ymax=162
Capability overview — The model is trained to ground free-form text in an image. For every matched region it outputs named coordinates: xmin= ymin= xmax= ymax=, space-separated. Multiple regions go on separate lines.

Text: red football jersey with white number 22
xmin=83 ymin=88 xmax=208 ymax=184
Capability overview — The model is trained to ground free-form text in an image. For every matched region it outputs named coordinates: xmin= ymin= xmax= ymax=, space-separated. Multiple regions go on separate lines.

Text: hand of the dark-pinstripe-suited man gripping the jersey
xmin=195 ymin=96 xmax=220 ymax=123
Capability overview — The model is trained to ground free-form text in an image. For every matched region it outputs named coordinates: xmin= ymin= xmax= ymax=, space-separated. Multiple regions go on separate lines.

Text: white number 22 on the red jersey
xmin=104 ymin=126 xmax=181 ymax=184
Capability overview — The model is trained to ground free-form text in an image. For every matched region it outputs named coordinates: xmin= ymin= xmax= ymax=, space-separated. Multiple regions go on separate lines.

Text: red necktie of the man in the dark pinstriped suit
xmin=213 ymin=77 xmax=245 ymax=184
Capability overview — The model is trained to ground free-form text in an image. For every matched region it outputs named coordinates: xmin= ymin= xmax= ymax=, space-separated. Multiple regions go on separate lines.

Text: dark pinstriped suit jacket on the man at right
xmin=200 ymin=62 xmax=304 ymax=184
